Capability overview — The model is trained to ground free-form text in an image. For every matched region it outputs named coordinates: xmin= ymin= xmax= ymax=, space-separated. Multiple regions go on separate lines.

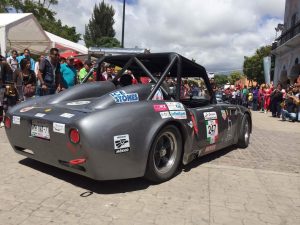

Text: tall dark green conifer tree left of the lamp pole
xmin=83 ymin=1 xmax=120 ymax=47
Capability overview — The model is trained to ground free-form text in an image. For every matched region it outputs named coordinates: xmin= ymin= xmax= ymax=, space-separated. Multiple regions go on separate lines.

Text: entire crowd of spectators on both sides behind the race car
xmin=0 ymin=48 xmax=300 ymax=127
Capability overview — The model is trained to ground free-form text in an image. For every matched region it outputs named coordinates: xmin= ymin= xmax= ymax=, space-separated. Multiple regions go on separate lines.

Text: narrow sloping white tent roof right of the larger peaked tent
xmin=46 ymin=31 xmax=88 ymax=54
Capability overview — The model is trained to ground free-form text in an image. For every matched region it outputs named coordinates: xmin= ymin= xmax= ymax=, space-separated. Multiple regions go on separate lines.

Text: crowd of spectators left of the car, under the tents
xmin=0 ymin=48 xmax=135 ymax=127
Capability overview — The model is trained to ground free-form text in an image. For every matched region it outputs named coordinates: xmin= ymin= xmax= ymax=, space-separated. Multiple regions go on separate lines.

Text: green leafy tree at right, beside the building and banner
xmin=243 ymin=45 xmax=274 ymax=84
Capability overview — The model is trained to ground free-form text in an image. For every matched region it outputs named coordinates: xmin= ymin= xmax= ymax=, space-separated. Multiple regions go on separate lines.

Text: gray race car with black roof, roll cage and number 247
xmin=5 ymin=53 xmax=252 ymax=182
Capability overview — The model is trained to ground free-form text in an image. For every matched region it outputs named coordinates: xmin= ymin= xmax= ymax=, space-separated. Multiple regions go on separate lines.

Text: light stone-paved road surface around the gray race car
xmin=0 ymin=112 xmax=300 ymax=225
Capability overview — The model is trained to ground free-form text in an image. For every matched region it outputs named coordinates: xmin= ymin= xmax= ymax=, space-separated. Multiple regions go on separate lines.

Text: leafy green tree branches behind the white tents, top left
xmin=0 ymin=0 xmax=81 ymax=42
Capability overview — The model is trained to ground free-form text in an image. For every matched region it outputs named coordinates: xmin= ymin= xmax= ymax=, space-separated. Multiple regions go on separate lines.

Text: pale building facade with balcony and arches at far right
xmin=272 ymin=0 xmax=300 ymax=86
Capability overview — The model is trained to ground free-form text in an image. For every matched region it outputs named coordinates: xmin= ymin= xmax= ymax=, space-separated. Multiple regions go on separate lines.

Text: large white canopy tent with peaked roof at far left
xmin=0 ymin=13 xmax=51 ymax=56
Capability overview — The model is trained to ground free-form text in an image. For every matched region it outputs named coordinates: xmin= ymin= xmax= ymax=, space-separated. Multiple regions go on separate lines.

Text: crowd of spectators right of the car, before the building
xmin=221 ymin=78 xmax=300 ymax=122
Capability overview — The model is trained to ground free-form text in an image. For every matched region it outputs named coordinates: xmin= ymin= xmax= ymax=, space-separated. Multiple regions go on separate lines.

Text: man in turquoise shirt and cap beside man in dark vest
xmin=60 ymin=56 xmax=77 ymax=90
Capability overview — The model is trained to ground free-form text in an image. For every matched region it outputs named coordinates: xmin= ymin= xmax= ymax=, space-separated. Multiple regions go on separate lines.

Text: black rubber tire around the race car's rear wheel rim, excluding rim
xmin=145 ymin=125 xmax=182 ymax=183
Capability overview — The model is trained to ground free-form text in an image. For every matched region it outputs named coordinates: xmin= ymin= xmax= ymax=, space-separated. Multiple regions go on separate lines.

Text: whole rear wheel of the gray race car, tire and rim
xmin=145 ymin=125 xmax=182 ymax=183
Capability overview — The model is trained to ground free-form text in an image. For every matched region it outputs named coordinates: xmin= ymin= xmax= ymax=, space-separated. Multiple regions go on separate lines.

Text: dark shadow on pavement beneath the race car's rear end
xmin=19 ymin=158 xmax=155 ymax=193
